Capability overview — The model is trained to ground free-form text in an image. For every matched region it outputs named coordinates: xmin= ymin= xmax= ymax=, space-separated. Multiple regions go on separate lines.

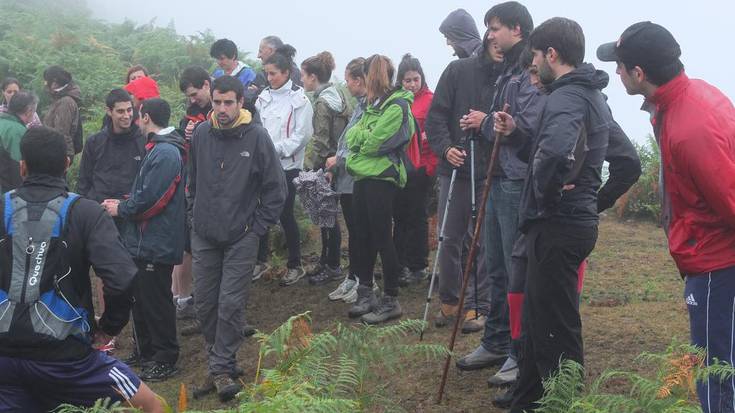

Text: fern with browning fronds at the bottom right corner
xmin=537 ymin=342 xmax=735 ymax=413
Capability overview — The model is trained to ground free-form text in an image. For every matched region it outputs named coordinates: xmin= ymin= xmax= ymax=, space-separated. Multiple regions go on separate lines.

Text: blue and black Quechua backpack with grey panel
xmin=0 ymin=191 xmax=91 ymax=347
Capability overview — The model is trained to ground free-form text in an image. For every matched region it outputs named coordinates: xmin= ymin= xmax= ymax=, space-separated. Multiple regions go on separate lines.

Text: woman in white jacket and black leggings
xmin=253 ymin=45 xmax=314 ymax=286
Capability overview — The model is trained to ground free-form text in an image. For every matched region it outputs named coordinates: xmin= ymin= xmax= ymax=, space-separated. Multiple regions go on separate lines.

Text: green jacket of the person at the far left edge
xmin=0 ymin=113 xmax=26 ymax=193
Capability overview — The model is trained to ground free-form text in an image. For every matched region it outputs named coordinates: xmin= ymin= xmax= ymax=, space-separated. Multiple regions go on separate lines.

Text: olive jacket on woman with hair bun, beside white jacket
xmin=309 ymin=83 xmax=352 ymax=169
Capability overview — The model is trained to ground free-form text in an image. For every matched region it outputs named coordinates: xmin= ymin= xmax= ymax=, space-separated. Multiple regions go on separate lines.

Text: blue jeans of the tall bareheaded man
xmin=482 ymin=177 xmax=523 ymax=353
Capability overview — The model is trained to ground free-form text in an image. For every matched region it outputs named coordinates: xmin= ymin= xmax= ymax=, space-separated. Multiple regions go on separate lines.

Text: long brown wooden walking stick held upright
xmin=436 ymin=104 xmax=509 ymax=404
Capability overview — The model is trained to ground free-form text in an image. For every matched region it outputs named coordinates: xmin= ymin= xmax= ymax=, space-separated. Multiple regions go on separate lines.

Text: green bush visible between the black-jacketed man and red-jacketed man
xmin=617 ymin=135 xmax=661 ymax=221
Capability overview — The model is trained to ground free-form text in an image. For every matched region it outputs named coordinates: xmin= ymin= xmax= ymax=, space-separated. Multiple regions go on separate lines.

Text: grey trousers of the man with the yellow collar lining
xmin=191 ymin=231 xmax=259 ymax=375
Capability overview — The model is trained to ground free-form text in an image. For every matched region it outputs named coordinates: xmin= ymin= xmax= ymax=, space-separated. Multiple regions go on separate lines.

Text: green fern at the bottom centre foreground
xmin=239 ymin=313 xmax=447 ymax=413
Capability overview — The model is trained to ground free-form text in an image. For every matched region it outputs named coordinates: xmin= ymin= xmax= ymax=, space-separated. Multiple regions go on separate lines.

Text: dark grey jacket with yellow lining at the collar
xmin=189 ymin=117 xmax=288 ymax=245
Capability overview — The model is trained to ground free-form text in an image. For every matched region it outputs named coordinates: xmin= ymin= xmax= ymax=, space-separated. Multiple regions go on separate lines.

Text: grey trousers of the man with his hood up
xmin=437 ymin=176 xmax=490 ymax=315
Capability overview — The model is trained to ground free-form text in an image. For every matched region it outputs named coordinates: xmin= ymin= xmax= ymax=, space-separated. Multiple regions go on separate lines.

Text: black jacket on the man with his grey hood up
xmin=424 ymin=52 xmax=498 ymax=179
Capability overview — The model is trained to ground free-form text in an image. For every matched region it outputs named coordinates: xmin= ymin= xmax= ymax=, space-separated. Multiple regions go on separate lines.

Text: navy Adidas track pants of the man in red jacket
xmin=684 ymin=267 xmax=735 ymax=413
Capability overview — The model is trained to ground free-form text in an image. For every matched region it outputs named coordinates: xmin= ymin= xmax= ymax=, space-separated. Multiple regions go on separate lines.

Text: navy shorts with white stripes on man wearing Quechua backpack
xmin=0 ymin=351 xmax=141 ymax=413
